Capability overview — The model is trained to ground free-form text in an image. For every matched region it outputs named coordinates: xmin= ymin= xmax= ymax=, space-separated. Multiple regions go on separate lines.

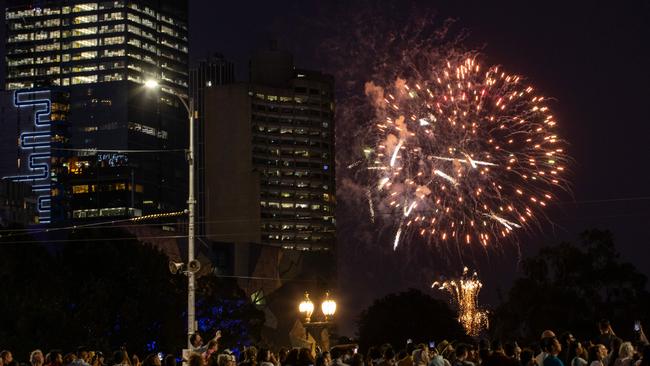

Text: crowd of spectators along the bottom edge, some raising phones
xmin=0 ymin=320 xmax=650 ymax=366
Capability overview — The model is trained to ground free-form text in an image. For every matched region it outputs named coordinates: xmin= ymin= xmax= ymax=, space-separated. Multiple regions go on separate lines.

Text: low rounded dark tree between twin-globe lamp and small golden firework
xmin=358 ymin=289 xmax=466 ymax=350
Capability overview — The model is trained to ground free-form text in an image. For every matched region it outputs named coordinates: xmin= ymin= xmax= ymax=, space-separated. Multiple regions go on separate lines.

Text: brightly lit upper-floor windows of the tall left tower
xmin=5 ymin=0 xmax=188 ymax=92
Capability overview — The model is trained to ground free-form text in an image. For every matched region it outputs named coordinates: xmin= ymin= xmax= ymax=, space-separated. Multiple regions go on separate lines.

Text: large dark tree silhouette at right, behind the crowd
xmin=490 ymin=230 xmax=650 ymax=340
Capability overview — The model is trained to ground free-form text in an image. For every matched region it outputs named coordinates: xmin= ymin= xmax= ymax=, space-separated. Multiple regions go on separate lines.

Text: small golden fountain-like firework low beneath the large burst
xmin=431 ymin=267 xmax=488 ymax=337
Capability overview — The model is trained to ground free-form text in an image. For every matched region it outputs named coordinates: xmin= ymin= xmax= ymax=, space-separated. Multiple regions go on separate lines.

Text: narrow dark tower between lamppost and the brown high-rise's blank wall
xmin=190 ymin=54 xmax=235 ymax=235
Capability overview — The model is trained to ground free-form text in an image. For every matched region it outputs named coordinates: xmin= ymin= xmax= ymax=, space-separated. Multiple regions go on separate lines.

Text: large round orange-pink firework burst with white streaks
xmin=366 ymin=55 xmax=567 ymax=248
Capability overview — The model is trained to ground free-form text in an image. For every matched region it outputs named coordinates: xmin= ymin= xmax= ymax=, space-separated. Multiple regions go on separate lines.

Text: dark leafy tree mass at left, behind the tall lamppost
xmin=0 ymin=228 xmax=263 ymax=361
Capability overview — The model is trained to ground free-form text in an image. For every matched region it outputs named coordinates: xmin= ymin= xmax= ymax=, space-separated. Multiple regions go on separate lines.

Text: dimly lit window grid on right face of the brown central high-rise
xmin=249 ymin=85 xmax=335 ymax=250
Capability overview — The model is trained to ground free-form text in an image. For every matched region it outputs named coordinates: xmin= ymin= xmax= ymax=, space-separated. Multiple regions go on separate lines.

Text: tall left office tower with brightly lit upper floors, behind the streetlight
xmin=5 ymin=0 xmax=188 ymax=219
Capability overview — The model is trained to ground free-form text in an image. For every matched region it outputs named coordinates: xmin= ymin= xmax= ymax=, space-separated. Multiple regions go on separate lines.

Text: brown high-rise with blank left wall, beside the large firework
xmin=204 ymin=47 xmax=336 ymax=276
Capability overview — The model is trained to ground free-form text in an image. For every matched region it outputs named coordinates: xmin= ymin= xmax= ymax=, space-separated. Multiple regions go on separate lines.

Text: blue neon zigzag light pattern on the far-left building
xmin=4 ymin=90 xmax=52 ymax=224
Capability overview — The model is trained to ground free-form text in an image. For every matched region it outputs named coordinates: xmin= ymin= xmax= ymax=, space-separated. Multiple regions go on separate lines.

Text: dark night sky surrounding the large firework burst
xmin=2 ymin=0 xmax=650 ymax=332
